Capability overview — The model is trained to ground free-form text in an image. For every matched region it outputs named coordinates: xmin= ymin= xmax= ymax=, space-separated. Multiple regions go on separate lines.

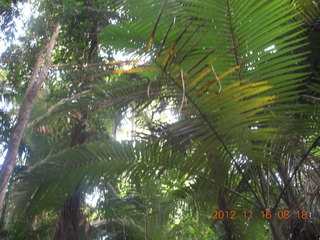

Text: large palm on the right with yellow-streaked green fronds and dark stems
xmin=98 ymin=1 xmax=319 ymax=236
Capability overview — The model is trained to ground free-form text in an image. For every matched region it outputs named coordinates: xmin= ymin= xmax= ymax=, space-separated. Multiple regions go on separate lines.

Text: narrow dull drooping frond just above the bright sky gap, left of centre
xmin=29 ymin=76 xmax=175 ymax=130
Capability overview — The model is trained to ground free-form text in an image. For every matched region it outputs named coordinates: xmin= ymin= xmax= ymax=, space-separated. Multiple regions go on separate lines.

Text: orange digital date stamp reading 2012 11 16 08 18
xmin=211 ymin=210 xmax=311 ymax=220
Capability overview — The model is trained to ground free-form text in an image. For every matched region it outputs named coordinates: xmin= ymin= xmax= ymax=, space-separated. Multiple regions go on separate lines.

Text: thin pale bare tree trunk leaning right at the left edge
xmin=0 ymin=24 xmax=61 ymax=211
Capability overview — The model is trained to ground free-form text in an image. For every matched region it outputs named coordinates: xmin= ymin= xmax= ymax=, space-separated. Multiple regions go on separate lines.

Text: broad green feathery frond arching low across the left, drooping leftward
xmin=14 ymin=142 xmax=188 ymax=214
